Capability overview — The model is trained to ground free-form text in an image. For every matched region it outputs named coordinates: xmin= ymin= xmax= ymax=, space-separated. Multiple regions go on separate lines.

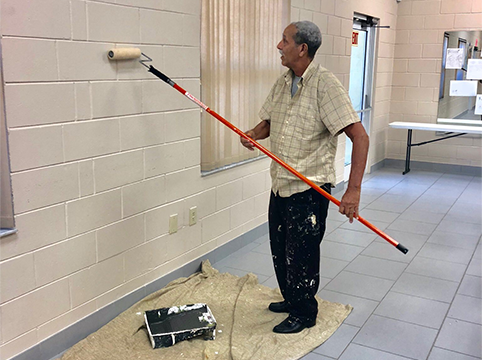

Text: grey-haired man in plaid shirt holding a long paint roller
xmin=241 ymin=21 xmax=368 ymax=334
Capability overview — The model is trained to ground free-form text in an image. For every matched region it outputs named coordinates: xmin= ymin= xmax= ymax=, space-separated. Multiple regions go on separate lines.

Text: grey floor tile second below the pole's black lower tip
xmin=392 ymin=273 xmax=459 ymax=303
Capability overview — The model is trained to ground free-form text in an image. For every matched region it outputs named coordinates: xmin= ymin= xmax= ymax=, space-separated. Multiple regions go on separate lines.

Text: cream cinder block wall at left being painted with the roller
xmin=0 ymin=0 xmax=276 ymax=359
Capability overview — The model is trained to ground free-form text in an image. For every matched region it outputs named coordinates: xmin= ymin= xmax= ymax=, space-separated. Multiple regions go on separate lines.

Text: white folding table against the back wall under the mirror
xmin=389 ymin=121 xmax=482 ymax=175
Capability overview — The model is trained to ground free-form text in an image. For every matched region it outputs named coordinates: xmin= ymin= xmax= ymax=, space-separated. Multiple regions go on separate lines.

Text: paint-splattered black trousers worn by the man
xmin=268 ymin=184 xmax=331 ymax=320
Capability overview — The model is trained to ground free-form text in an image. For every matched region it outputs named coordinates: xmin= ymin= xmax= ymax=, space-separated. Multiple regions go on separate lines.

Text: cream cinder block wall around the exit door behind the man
xmin=291 ymin=0 xmax=398 ymax=183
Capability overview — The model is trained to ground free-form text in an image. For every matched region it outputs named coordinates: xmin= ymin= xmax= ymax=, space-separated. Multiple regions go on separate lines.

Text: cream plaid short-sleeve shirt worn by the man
xmin=259 ymin=62 xmax=360 ymax=197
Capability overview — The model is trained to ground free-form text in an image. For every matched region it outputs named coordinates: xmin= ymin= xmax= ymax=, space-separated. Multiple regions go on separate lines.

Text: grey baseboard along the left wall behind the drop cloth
xmin=11 ymin=223 xmax=268 ymax=360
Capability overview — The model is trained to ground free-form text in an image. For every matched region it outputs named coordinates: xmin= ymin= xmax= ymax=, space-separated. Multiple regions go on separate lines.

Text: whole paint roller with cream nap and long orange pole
xmin=107 ymin=48 xmax=408 ymax=254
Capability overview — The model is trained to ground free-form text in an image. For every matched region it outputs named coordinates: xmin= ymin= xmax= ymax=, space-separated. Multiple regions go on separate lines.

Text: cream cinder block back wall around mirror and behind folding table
xmin=387 ymin=0 xmax=482 ymax=166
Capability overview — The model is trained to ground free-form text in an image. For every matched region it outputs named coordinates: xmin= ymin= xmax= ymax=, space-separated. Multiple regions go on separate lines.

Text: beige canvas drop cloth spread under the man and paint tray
xmin=62 ymin=261 xmax=352 ymax=360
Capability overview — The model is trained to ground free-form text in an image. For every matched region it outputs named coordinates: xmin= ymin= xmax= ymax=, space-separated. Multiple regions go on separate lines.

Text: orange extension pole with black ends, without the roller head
xmin=146 ymin=65 xmax=408 ymax=254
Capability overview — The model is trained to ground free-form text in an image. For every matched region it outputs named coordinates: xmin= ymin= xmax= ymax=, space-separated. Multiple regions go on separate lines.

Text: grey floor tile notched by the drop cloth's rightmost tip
xmin=318 ymin=289 xmax=379 ymax=327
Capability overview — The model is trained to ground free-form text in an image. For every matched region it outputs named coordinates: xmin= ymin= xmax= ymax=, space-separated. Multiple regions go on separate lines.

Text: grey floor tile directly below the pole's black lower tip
xmin=405 ymin=256 xmax=467 ymax=282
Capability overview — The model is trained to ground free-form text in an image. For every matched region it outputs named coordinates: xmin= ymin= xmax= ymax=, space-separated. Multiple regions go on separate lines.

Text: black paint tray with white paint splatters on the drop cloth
xmin=144 ymin=304 xmax=216 ymax=349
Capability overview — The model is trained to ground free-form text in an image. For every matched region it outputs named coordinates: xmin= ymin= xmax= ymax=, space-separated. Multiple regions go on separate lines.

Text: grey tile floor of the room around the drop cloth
xmin=214 ymin=168 xmax=482 ymax=360
